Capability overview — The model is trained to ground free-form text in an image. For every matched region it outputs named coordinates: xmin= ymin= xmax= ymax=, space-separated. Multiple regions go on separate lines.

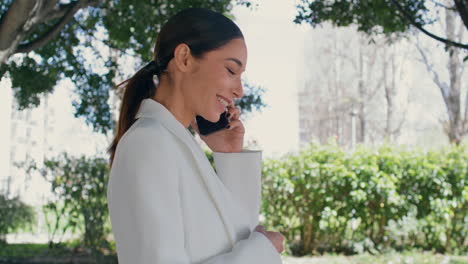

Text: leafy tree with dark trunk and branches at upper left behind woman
xmin=0 ymin=0 xmax=261 ymax=133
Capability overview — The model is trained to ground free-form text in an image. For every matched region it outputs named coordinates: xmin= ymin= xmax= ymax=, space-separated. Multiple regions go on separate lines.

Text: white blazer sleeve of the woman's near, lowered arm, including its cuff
xmin=107 ymin=131 xmax=281 ymax=264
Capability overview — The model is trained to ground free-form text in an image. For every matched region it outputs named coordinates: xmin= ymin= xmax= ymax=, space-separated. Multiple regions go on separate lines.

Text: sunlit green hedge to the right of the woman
xmin=262 ymin=143 xmax=468 ymax=255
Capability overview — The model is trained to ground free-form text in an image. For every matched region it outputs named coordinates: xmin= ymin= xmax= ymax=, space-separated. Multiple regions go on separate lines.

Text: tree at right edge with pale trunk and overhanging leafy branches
xmin=294 ymin=0 xmax=468 ymax=144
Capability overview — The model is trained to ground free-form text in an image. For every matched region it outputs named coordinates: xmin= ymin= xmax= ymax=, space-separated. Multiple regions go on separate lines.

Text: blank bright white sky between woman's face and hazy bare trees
xmin=234 ymin=0 xmax=304 ymax=157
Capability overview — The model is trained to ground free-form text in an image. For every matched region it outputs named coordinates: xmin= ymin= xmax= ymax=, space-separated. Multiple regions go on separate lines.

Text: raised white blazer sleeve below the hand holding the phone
xmin=213 ymin=150 xmax=262 ymax=230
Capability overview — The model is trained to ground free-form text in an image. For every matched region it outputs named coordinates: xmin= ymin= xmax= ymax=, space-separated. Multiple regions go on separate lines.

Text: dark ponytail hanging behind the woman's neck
xmin=108 ymin=61 xmax=161 ymax=165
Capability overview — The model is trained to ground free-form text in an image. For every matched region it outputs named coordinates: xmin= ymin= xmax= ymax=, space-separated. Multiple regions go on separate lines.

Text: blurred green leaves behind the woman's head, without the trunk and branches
xmin=0 ymin=0 xmax=262 ymax=133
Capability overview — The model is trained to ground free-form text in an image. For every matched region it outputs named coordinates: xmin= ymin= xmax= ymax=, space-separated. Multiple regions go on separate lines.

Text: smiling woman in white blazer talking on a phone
xmin=107 ymin=8 xmax=284 ymax=264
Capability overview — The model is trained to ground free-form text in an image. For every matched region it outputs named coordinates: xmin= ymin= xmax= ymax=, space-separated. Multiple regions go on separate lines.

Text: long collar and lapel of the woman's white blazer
xmin=135 ymin=98 xmax=235 ymax=247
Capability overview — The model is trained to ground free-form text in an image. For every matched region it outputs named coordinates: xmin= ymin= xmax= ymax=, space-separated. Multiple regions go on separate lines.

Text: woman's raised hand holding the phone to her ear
xmin=191 ymin=103 xmax=245 ymax=152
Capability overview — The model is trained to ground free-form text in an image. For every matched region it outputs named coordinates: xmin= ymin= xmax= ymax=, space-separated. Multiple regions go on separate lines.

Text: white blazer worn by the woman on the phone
xmin=107 ymin=99 xmax=282 ymax=264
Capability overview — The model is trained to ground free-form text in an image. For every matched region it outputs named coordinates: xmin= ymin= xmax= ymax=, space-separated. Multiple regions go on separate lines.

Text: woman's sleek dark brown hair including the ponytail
xmin=108 ymin=8 xmax=243 ymax=165
